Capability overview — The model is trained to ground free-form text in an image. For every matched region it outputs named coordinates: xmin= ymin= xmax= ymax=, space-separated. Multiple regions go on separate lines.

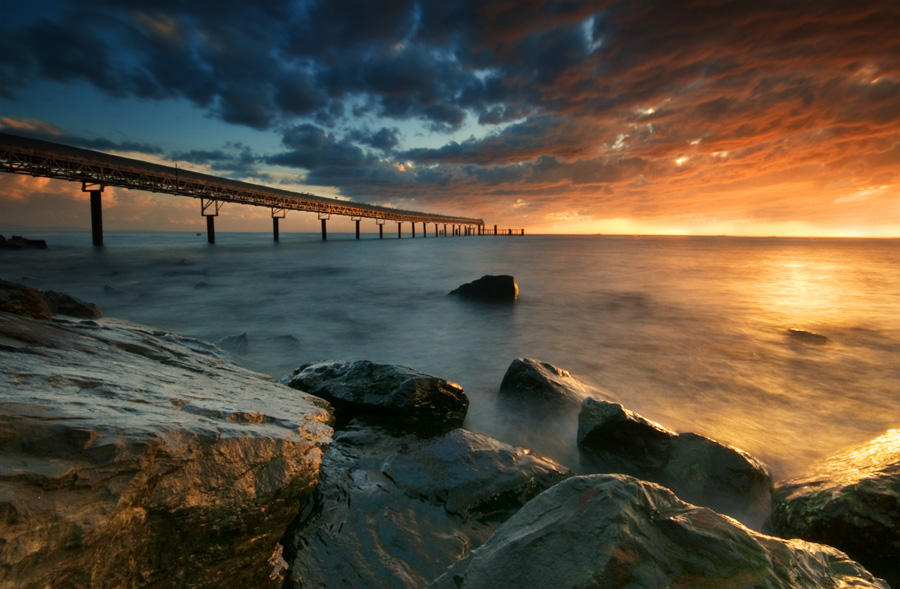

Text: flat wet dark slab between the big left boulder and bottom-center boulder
xmin=285 ymin=421 xmax=568 ymax=589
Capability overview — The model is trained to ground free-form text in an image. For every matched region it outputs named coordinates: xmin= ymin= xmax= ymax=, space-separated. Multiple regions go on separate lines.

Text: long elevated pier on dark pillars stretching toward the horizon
xmin=0 ymin=133 xmax=525 ymax=246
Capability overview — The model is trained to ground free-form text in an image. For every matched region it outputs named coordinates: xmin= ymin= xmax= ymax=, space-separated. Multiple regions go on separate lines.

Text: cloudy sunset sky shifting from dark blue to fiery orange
xmin=0 ymin=0 xmax=900 ymax=237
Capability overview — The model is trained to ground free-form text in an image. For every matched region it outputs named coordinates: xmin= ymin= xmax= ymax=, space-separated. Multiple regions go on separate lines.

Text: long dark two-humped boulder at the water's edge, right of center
xmin=578 ymin=398 xmax=772 ymax=528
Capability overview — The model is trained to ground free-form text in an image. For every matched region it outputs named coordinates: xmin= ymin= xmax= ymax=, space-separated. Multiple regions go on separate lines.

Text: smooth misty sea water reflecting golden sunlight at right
xmin=0 ymin=232 xmax=900 ymax=478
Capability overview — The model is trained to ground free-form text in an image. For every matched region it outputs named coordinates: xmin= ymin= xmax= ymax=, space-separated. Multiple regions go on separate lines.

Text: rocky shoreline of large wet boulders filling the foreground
xmin=0 ymin=283 xmax=900 ymax=588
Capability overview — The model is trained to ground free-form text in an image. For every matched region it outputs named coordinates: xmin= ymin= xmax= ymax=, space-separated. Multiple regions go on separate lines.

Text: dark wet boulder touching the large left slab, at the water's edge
xmin=285 ymin=360 xmax=469 ymax=429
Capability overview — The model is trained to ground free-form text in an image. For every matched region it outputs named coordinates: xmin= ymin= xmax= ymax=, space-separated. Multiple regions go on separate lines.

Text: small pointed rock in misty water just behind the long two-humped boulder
xmin=497 ymin=358 xmax=599 ymax=411
